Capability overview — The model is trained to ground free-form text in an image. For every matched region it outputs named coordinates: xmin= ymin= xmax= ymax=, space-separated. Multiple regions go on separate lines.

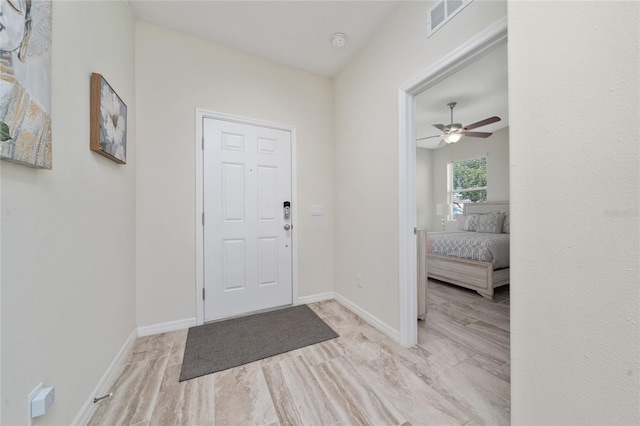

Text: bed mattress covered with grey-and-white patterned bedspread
xmin=427 ymin=231 xmax=509 ymax=269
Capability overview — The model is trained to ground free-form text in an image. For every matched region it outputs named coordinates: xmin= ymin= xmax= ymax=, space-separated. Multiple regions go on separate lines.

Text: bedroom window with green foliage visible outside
xmin=447 ymin=156 xmax=487 ymax=219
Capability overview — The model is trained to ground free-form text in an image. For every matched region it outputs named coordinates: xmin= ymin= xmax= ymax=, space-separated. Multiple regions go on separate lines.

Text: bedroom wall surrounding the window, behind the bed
xmin=429 ymin=127 xmax=509 ymax=230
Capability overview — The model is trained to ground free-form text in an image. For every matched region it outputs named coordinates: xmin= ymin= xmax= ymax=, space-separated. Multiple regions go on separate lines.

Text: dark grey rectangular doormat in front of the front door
xmin=180 ymin=305 xmax=338 ymax=382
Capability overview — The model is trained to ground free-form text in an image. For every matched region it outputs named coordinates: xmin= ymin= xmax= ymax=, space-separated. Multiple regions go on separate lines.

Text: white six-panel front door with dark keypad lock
xmin=203 ymin=118 xmax=292 ymax=321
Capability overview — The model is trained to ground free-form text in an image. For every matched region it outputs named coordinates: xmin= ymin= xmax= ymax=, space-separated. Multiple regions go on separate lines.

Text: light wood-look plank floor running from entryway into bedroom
xmin=89 ymin=281 xmax=510 ymax=426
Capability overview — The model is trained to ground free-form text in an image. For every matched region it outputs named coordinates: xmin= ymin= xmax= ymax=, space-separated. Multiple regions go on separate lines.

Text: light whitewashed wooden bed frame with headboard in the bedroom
xmin=418 ymin=201 xmax=510 ymax=312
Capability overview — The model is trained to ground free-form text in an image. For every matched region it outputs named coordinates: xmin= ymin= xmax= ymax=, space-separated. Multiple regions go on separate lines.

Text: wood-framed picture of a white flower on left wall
xmin=89 ymin=73 xmax=127 ymax=164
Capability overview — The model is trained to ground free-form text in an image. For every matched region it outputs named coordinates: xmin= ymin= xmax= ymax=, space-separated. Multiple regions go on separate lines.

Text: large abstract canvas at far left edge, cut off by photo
xmin=0 ymin=0 xmax=52 ymax=169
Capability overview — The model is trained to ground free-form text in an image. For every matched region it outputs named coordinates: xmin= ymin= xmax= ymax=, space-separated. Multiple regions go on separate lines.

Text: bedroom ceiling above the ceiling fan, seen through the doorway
xmin=416 ymin=43 xmax=509 ymax=149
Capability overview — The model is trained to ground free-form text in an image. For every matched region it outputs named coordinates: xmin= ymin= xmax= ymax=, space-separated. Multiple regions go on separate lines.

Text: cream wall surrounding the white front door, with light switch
xmin=136 ymin=22 xmax=334 ymax=326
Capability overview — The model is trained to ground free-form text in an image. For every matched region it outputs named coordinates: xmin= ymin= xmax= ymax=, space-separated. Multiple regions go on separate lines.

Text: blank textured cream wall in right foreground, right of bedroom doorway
xmin=509 ymin=1 xmax=640 ymax=425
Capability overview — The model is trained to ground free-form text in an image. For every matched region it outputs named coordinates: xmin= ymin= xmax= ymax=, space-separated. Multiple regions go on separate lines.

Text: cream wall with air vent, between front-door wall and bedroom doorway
xmin=334 ymin=1 xmax=506 ymax=330
